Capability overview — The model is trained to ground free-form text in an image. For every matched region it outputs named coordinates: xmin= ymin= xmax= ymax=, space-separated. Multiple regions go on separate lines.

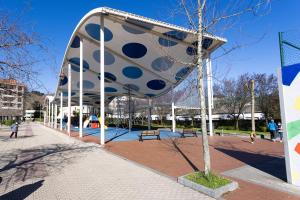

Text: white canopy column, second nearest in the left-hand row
xmin=79 ymin=38 xmax=83 ymax=137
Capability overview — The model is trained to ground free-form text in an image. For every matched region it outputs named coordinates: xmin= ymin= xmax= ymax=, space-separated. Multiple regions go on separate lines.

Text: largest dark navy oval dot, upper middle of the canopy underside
xmin=122 ymin=43 xmax=147 ymax=58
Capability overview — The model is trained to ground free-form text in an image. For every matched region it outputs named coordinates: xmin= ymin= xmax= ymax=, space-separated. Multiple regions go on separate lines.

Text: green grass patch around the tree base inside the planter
xmin=185 ymin=172 xmax=231 ymax=189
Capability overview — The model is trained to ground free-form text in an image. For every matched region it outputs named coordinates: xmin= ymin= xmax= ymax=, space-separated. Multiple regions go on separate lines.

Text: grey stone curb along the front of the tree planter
xmin=178 ymin=175 xmax=239 ymax=199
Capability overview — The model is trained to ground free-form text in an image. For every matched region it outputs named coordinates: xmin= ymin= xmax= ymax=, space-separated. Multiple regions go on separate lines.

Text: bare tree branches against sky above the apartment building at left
xmin=0 ymin=9 xmax=51 ymax=92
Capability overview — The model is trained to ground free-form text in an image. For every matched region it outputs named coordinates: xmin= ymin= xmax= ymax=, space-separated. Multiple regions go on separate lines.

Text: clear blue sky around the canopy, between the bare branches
xmin=0 ymin=0 xmax=300 ymax=92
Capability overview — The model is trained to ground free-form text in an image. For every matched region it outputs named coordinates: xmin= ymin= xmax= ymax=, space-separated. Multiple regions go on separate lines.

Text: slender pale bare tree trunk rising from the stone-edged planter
xmin=197 ymin=0 xmax=210 ymax=175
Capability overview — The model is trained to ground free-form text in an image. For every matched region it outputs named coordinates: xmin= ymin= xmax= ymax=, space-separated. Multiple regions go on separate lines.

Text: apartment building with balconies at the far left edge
xmin=0 ymin=79 xmax=25 ymax=121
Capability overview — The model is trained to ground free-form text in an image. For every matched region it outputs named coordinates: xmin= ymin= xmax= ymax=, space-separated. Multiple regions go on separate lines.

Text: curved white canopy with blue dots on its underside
xmin=55 ymin=8 xmax=226 ymax=105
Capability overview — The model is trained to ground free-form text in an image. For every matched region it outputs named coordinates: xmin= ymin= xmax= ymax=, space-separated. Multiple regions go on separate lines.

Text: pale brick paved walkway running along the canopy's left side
xmin=0 ymin=124 xmax=210 ymax=200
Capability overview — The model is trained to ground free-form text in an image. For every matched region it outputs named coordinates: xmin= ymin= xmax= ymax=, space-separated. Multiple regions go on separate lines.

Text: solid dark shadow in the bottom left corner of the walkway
xmin=0 ymin=180 xmax=44 ymax=200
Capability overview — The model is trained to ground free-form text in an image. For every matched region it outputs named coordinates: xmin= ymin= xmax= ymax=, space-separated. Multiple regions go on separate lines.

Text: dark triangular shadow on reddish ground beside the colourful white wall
xmin=215 ymin=148 xmax=287 ymax=181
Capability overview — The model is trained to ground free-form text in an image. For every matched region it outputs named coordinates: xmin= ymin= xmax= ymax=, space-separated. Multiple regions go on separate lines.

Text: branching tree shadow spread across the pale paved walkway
xmin=0 ymin=144 xmax=95 ymax=188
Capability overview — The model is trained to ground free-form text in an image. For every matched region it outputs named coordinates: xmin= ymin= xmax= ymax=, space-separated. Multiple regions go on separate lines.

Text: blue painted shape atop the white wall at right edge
xmin=281 ymin=63 xmax=300 ymax=86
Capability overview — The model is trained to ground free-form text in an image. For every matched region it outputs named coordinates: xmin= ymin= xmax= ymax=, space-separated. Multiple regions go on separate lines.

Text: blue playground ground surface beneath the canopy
xmin=72 ymin=127 xmax=180 ymax=142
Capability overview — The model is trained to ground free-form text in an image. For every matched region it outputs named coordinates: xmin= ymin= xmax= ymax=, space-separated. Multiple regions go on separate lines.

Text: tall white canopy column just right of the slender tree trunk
xmin=206 ymin=57 xmax=213 ymax=136
